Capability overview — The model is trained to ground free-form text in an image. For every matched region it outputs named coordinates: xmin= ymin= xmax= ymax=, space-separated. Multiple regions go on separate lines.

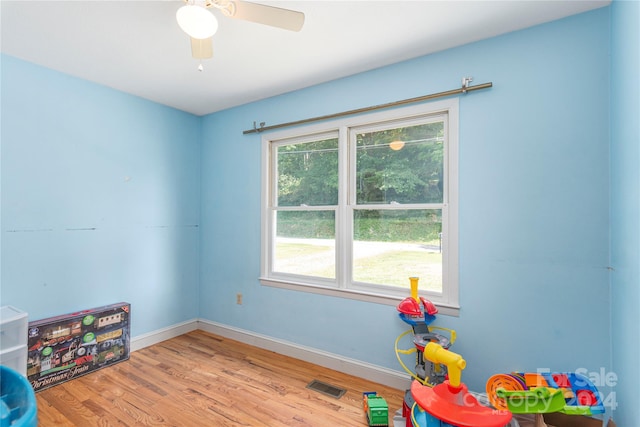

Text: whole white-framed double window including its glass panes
xmin=261 ymin=99 xmax=458 ymax=314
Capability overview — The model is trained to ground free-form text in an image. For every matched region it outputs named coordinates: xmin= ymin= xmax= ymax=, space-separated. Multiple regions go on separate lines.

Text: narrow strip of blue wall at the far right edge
xmin=611 ymin=1 xmax=640 ymax=426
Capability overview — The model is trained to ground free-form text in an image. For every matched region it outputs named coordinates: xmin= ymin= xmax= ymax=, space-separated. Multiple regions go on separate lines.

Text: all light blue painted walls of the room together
xmin=0 ymin=1 xmax=640 ymax=426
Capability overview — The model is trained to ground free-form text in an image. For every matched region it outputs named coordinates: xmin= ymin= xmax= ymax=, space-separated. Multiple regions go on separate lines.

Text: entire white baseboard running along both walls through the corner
xmin=131 ymin=319 xmax=410 ymax=390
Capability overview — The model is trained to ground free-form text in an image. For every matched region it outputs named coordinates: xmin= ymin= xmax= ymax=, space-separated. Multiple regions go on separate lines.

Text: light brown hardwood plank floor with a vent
xmin=36 ymin=331 xmax=404 ymax=427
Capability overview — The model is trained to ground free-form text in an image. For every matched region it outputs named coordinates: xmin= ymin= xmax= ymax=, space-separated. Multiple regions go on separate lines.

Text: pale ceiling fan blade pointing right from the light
xmin=229 ymin=0 xmax=304 ymax=31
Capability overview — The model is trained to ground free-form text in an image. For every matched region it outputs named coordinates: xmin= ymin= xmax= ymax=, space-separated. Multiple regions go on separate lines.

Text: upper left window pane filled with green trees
xmin=276 ymin=138 xmax=338 ymax=206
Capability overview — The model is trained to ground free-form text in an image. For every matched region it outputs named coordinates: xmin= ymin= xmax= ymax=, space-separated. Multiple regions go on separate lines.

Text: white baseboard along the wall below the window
xmin=198 ymin=319 xmax=411 ymax=390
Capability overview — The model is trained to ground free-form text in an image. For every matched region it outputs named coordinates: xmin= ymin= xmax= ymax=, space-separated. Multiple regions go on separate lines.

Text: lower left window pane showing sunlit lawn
xmin=273 ymin=211 xmax=336 ymax=279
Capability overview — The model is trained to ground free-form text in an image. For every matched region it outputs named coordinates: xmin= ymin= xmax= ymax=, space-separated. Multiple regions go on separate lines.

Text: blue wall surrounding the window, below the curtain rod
xmin=200 ymin=8 xmax=611 ymax=396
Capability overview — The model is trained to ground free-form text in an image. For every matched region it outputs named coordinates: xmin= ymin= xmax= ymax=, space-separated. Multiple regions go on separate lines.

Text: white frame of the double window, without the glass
xmin=260 ymin=98 xmax=460 ymax=315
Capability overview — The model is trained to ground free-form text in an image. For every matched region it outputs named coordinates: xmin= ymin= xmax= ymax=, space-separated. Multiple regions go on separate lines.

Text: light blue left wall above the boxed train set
xmin=0 ymin=56 xmax=201 ymax=336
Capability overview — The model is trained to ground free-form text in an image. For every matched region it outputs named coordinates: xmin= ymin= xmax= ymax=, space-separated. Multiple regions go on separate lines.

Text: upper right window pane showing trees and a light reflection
xmin=356 ymin=121 xmax=444 ymax=204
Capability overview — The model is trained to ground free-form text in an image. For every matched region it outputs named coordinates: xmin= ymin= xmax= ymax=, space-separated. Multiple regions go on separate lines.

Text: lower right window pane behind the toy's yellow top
xmin=353 ymin=209 xmax=442 ymax=292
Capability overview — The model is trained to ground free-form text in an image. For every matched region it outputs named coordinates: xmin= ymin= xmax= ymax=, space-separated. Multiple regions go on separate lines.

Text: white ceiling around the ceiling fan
xmin=0 ymin=0 xmax=610 ymax=115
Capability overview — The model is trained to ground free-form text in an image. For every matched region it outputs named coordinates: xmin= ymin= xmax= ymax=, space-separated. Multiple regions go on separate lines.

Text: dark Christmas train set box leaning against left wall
xmin=27 ymin=302 xmax=131 ymax=391
